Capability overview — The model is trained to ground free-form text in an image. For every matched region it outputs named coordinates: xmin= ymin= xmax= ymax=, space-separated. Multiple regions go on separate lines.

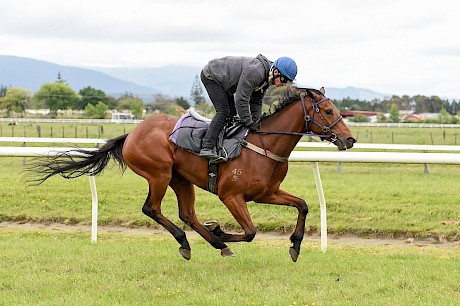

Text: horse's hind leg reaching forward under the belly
xmin=169 ymin=173 xmax=233 ymax=256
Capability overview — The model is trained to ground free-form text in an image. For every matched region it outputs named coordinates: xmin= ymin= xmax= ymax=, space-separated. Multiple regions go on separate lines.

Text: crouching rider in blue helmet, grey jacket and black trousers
xmin=200 ymin=54 xmax=297 ymax=161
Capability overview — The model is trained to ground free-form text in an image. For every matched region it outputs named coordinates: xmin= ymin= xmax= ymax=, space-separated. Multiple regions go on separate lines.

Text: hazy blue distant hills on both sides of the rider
xmin=0 ymin=55 xmax=390 ymax=102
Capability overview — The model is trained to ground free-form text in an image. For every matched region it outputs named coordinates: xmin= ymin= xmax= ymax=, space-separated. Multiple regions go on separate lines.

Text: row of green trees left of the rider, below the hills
xmin=0 ymin=73 xmax=209 ymax=118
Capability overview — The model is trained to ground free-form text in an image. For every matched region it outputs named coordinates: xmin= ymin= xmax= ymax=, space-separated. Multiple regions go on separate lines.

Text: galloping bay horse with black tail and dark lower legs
xmin=28 ymin=87 xmax=356 ymax=262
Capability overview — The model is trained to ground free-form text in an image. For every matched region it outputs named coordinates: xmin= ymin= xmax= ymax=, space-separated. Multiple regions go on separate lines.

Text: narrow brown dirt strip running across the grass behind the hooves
xmin=0 ymin=222 xmax=460 ymax=248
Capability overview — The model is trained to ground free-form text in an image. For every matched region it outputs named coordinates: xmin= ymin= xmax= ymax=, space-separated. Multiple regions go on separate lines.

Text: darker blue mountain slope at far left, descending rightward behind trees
xmin=0 ymin=55 xmax=159 ymax=95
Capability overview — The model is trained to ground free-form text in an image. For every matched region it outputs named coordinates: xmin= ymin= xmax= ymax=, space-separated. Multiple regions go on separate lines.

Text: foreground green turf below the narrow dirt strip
xmin=0 ymin=228 xmax=460 ymax=305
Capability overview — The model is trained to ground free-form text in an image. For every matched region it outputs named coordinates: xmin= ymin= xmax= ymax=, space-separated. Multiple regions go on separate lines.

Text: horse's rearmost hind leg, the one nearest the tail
xmin=142 ymin=182 xmax=191 ymax=260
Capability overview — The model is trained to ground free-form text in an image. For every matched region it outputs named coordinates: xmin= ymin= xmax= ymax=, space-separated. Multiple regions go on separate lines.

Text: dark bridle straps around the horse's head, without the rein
xmin=300 ymin=95 xmax=343 ymax=142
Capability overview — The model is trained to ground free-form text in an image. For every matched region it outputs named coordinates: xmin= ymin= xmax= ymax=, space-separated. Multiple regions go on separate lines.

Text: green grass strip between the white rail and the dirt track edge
xmin=0 ymin=158 xmax=460 ymax=241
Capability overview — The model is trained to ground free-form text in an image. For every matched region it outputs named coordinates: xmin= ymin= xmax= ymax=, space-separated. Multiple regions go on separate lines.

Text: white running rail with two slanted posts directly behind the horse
xmin=0 ymin=137 xmax=460 ymax=251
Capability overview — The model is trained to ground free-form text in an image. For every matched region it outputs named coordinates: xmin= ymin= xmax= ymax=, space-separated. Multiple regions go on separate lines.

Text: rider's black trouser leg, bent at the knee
xmin=200 ymin=71 xmax=236 ymax=149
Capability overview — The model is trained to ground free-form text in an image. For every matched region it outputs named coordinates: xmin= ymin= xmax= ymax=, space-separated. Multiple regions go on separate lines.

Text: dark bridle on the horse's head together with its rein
xmin=255 ymin=94 xmax=343 ymax=143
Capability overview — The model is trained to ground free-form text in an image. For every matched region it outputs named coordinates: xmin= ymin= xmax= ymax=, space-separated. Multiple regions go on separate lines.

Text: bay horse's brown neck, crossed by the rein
xmin=261 ymin=101 xmax=305 ymax=156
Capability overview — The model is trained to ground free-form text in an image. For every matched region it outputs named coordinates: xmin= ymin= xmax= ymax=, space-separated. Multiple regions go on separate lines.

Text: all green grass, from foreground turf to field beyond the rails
xmin=0 ymin=125 xmax=460 ymax=305
